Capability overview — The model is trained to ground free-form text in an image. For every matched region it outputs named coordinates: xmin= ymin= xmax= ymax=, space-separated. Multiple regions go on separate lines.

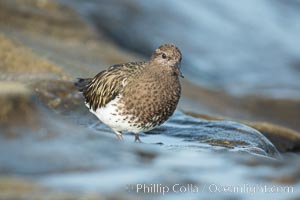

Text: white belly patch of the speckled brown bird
xmin=86 ymin=97 xmax=153 ymax=133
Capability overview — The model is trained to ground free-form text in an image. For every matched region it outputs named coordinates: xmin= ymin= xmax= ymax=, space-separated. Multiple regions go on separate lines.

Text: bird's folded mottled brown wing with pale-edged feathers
xmin=82 ymin=62 xmax=144 ymax=110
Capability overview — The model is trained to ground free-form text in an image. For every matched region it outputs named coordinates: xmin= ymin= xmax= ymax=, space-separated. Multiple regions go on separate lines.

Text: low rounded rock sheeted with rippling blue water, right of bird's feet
xmin=153 ymin=112 xmax=280 ymax=158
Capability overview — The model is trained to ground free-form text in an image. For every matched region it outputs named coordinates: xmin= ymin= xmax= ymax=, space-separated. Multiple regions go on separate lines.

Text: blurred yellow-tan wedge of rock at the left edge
xmin=0 ymin=33 xmax=67 ymax=83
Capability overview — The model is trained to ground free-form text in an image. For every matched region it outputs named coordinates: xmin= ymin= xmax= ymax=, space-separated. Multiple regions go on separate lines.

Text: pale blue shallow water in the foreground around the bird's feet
xmin=0 ymin=94 xmax=299 ymax=199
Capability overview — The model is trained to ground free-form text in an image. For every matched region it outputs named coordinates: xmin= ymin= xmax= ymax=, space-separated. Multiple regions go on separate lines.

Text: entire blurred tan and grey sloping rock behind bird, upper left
xmin=0 ymin=0 xmax=141 ymax=80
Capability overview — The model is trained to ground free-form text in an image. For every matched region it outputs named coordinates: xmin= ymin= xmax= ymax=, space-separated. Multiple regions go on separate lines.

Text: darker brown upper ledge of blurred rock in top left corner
xmin=0 ymin=0 xmax=97 ymax=41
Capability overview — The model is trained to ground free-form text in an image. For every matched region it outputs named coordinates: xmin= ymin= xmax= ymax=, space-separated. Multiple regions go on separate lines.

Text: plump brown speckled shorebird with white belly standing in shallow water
xmin=75 ymin=44 xmax=184 ymax=142
